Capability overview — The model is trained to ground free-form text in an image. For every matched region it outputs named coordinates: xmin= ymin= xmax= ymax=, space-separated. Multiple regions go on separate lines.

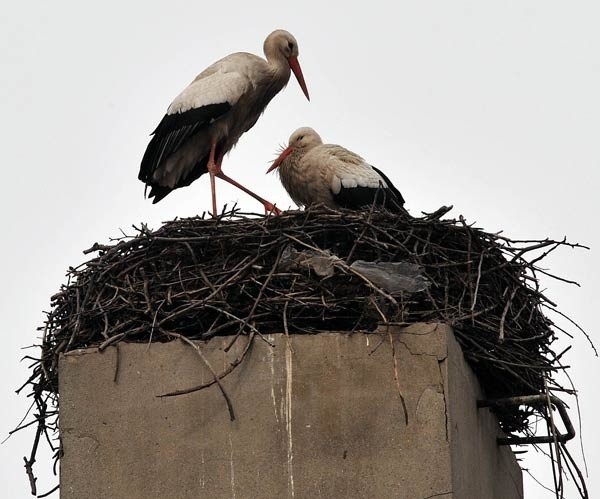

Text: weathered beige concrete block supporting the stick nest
xmin=60 ymin=324 xmax=522 ymax=499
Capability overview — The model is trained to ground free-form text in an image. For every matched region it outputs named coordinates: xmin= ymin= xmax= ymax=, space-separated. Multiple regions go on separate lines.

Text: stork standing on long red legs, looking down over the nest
xmin=138 ymin=30 xmax=310 ymax=216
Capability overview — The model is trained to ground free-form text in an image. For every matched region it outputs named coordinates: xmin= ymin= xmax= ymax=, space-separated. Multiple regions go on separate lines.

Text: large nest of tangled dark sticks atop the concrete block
xmin=18 ymin=208 xmax=592 ymax=498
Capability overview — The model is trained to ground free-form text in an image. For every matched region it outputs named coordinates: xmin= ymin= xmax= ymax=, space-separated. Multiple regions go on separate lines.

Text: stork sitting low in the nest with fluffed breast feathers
xmin=267 ymin=127 xmax=405 ymax=212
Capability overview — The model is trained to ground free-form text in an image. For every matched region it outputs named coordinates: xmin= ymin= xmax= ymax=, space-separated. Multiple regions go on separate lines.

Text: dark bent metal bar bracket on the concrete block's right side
xmin=477 ymin=393 xmax=575 ymax=445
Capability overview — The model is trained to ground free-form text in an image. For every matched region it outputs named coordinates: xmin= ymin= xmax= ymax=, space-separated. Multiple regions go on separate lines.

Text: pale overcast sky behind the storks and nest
xmin=0 ymin=0 xmax=600 ymax=499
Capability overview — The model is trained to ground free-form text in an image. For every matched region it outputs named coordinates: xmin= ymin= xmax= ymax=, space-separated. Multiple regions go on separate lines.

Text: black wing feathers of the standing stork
xmin=138 ymin=102 xmax=231 ymax=184
